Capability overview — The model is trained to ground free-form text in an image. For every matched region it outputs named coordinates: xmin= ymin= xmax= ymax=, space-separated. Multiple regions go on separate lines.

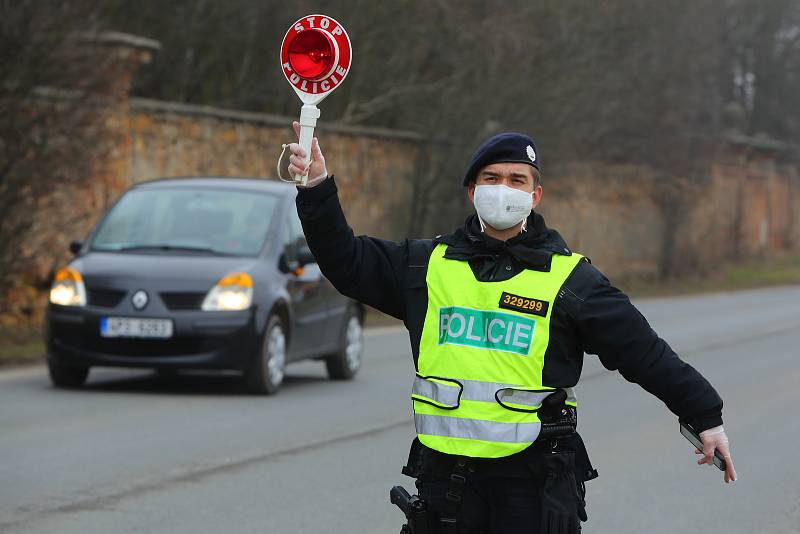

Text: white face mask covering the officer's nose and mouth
xmin=474 ymin=185 xmax=533 ymax=230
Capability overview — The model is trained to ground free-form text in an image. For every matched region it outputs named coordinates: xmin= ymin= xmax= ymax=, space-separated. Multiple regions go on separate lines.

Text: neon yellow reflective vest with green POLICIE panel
xmin=411 ymin=244 xmax=583 ymax=458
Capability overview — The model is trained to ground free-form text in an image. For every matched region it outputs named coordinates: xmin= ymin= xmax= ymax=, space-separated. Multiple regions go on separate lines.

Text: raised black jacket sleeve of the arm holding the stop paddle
xmin=296 ymin=176 xmax=408 ymax=320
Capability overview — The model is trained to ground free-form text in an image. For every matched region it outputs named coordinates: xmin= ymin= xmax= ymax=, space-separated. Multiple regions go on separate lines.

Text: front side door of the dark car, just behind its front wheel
xmin=284 ymin=209 xmax=330 ymax=358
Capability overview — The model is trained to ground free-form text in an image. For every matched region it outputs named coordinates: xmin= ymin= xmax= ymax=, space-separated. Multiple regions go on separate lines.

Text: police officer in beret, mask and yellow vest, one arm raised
xmin=289 ymin=126 xmax=736 ymax=534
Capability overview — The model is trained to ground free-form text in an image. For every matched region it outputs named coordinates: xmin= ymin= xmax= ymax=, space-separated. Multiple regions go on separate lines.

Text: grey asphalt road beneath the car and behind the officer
xmin=0 ymin=287 xmax=800 ymax=534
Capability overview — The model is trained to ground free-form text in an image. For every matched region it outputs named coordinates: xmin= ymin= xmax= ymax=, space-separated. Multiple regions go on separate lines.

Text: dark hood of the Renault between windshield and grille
xmin=71 ymin=252 xmax=258 ymax=291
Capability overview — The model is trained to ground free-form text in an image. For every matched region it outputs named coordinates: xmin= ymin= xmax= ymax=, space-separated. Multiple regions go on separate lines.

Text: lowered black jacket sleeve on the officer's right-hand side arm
xmin=573 ymin=263 xmax=722 ymax=432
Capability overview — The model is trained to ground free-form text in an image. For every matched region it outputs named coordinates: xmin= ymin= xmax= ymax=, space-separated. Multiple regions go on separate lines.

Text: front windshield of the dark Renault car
xmin=91 ymin=187 xmax=278 ymax=256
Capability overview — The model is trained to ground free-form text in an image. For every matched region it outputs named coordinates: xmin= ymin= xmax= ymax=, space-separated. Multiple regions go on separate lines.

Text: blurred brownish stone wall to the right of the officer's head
xmin=540 ymin=142 xmax=800 ymax=280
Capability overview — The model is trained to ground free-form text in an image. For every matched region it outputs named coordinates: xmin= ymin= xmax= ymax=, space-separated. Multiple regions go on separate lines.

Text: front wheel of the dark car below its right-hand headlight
xmin=245 ymin=315 xmax=287 ymax=395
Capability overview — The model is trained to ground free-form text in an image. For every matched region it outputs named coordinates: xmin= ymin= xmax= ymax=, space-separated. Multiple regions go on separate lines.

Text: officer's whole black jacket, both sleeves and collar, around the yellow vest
xmin=297 ymin=177 xmax=722 ymax=438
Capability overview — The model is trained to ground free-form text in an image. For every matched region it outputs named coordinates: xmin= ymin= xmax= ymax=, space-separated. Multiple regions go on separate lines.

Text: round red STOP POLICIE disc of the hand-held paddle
xmin=281 ymin=15 xmax=352 ymax=104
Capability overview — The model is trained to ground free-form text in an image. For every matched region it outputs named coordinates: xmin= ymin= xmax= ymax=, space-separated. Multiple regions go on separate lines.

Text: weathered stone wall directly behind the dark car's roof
xmin=123 ymin=99 xmax=420 ymax=237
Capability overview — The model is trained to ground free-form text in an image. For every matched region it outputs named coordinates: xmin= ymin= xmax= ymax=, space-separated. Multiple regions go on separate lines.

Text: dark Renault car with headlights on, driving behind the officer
xmin=46 ymin=178 xmax=364 ymax=393
